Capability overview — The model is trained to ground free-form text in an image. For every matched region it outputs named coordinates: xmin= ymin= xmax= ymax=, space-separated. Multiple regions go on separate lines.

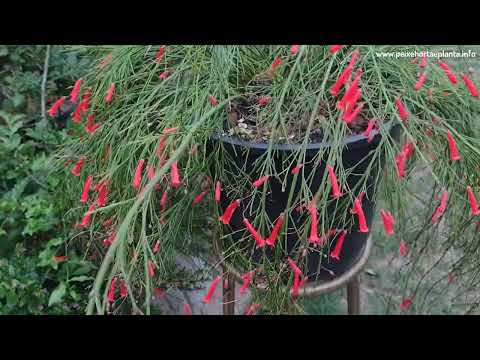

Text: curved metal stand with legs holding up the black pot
xmin=215 ymin=237 xmax=373 ymax=315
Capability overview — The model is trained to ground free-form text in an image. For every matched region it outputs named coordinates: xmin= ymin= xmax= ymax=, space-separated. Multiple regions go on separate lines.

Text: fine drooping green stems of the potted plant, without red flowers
xmin=54 ymin=45 xmax=480 ymax=313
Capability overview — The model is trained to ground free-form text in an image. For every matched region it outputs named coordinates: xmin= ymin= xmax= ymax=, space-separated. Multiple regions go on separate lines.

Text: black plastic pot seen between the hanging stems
xmin=210 ymin=126 xmax=400 ymax=280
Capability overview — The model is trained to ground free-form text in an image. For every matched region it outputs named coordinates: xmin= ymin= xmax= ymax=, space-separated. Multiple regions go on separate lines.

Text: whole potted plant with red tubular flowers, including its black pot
xmin=53 ymin=45 xmax=480 ymax=313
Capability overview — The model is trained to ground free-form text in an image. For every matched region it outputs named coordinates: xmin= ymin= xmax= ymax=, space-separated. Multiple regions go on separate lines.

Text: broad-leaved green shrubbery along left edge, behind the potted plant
xmin=0 ymin=45 xmax=93 ymax=314
